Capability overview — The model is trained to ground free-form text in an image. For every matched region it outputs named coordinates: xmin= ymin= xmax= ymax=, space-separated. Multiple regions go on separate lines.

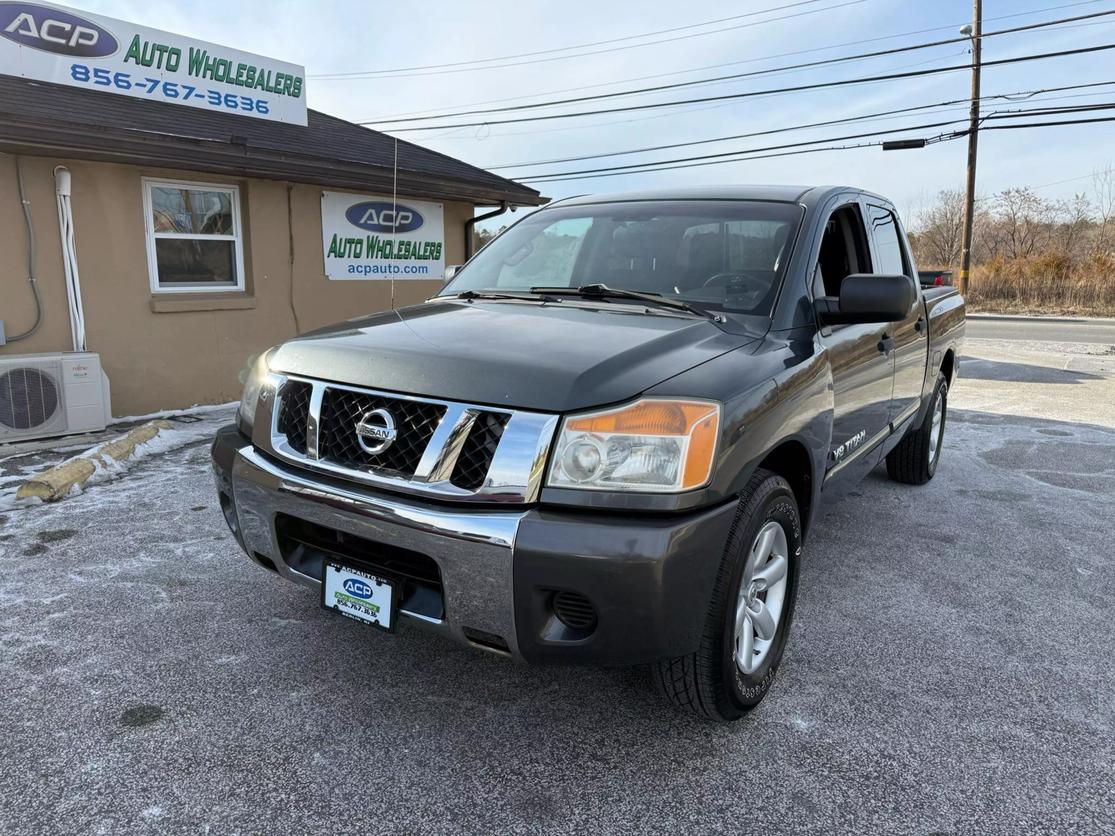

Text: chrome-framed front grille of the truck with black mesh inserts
xmin=252 ymin=373 xmax=558 ymax=503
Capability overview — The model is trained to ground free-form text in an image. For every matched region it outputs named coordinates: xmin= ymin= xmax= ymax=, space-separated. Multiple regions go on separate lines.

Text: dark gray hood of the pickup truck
xmin=271 ymin=300 xmax=762 ymax=412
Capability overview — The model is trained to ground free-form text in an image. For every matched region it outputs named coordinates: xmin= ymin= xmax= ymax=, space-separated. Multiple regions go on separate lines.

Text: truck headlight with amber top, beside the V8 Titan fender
xmin=546 ymin=398 xmax=720 ymax=493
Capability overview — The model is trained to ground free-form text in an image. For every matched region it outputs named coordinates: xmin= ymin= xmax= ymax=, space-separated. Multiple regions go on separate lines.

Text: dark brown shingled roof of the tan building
xmin=0 ymin=76 xmax=546 ymax=206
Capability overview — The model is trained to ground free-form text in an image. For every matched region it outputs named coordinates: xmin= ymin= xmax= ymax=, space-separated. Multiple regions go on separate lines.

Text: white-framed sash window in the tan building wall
xmin=143 ymin=178 xmax=244 ymax=293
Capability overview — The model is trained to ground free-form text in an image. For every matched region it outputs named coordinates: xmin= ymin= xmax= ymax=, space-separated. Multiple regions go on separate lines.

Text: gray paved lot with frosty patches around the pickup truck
xmin=0 ymin=340 xmax=1115 ymax=834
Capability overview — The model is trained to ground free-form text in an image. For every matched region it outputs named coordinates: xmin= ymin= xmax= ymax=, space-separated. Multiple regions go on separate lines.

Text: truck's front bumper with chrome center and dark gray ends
xmin=212 ymin=426 xmax=736 ymax=664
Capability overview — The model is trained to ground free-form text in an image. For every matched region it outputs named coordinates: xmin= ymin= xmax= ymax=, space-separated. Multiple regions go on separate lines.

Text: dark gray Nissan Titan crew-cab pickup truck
xmin=213 ymin=186 xmax=964 ymax=720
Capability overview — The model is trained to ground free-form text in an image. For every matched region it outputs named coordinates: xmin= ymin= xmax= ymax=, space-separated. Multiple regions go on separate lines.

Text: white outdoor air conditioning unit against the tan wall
xmin=0 ymin=351 xmax=112 ymax=444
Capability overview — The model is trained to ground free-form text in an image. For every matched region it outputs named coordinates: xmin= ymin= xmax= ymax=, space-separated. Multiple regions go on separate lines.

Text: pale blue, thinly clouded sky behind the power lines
xmin=75 ymin=0 xmax=1115 ymax=224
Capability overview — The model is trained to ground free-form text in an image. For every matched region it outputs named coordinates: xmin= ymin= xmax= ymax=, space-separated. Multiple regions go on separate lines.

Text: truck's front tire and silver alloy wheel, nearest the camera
xmin=653 ymin=469 xmax=802 ymax=721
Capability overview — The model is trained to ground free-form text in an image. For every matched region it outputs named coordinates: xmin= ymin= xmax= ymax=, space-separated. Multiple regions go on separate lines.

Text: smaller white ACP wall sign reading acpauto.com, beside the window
xmin=321 ymin=192 xmax=445 ymax=280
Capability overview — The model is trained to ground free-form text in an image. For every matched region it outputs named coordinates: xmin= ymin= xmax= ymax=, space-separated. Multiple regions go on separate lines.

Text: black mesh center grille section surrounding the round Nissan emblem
xmin=318 ymin=387 xmax=443 ymax=478
